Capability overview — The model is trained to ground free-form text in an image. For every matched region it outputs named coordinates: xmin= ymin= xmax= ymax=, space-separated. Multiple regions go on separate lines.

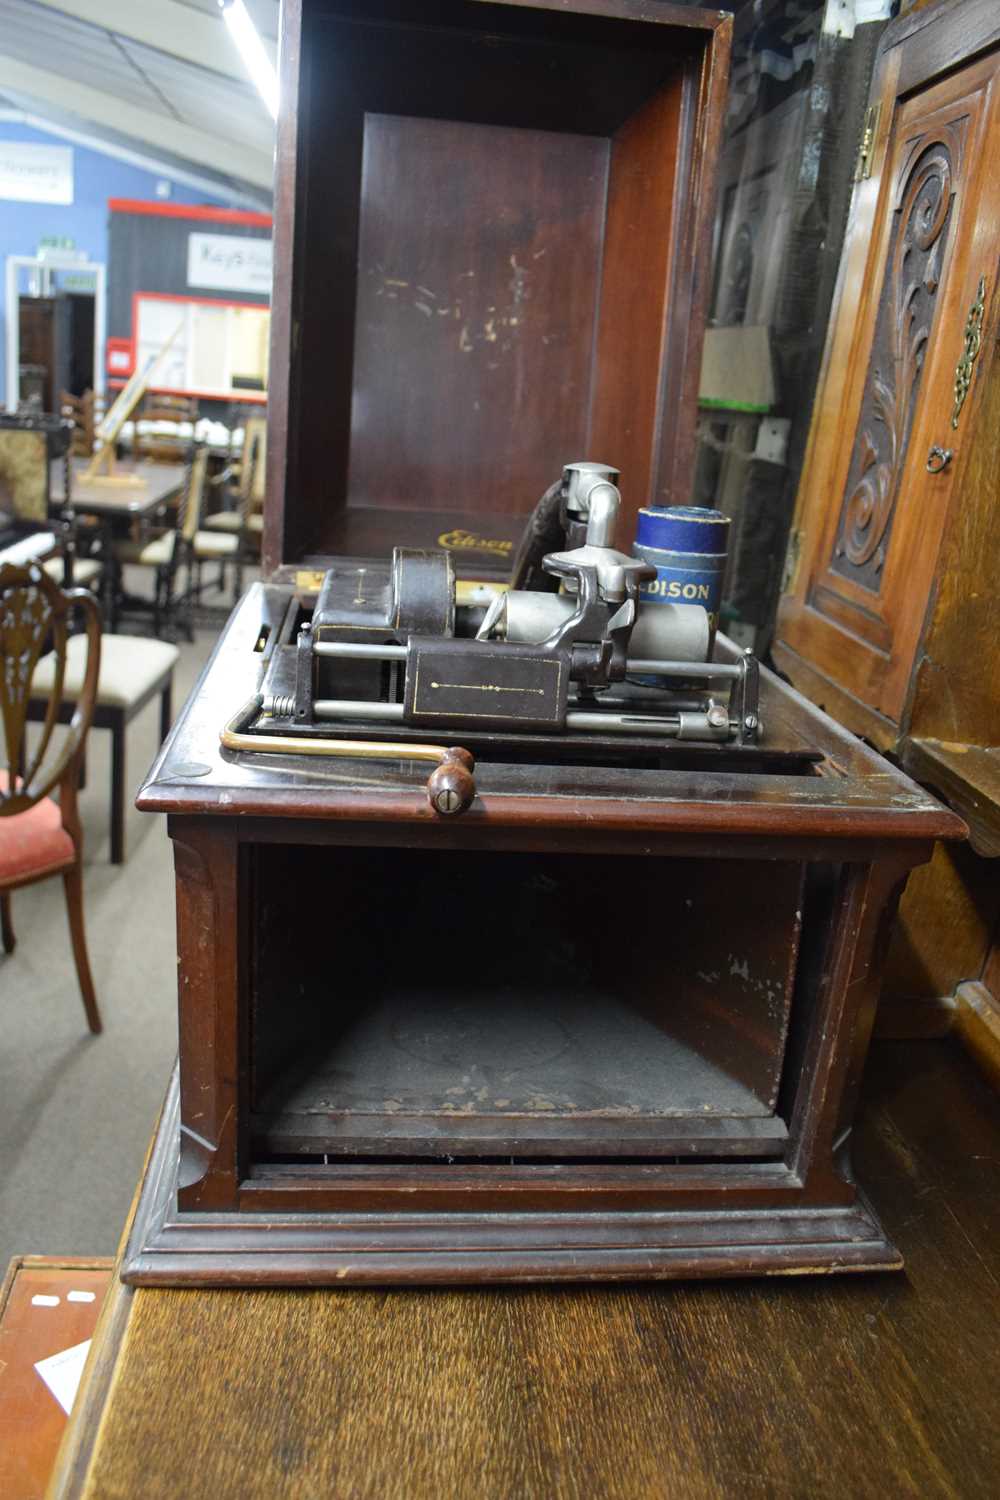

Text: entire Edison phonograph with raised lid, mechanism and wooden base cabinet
xmin=124 ymin=0 xmax=964 ymax=1284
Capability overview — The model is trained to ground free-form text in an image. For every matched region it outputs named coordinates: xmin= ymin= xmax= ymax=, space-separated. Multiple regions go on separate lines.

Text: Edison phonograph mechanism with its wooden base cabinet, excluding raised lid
xmin=126 ymin=464 xmax=960 ymax=1284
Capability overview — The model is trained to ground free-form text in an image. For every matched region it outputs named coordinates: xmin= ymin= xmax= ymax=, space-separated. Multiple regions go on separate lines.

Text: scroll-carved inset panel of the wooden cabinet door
xmin=832 ymin=124 xmax=969 ymax=593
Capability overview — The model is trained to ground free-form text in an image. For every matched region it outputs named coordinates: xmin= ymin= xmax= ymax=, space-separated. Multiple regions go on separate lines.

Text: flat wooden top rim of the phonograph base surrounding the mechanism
xmin=136 ymin=584 xmax=967 ymax=842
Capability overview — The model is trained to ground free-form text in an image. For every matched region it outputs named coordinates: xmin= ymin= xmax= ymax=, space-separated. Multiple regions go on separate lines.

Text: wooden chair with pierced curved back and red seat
xmin=0 ymin=563 xmax=100 ymax=1032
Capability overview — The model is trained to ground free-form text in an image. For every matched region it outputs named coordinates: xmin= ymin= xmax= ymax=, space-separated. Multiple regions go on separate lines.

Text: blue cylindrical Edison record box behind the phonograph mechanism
xmin=634 ymin=506 xmax=729 ymax=636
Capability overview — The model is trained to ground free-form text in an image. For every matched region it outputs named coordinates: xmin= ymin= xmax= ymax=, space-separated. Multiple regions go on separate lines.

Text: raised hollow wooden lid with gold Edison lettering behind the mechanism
xmin=264 ymin=0 xmax=730 ymax=576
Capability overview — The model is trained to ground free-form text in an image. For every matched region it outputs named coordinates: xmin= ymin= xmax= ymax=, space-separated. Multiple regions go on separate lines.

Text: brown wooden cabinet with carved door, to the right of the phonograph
xmin=774 ymin=0 xmax=1000 ymax=1070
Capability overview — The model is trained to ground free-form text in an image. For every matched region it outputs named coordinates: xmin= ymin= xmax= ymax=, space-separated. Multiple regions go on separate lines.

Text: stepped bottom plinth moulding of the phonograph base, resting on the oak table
xmin=121 ymin=1074 xmax=903 ymax=1287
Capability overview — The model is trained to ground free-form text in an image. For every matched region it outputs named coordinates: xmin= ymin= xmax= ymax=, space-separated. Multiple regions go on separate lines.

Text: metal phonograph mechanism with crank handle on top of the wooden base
xmin=222 ymin=462 xmax=767 ymax=816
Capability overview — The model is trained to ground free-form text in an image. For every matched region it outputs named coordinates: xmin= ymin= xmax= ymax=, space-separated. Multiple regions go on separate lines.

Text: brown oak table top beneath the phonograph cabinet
xmin=49 ymin=1041 xmax=1000 ymax=1500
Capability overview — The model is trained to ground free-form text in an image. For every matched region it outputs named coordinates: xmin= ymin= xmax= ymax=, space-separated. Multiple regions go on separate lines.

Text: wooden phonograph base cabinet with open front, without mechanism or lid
xmin=124 ymin=585 xmax=964 ymax=1286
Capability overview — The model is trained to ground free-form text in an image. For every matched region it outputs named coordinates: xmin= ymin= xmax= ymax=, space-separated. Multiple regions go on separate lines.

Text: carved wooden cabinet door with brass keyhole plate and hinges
xmin=775 ymin=0 xmax=1000 ymax=741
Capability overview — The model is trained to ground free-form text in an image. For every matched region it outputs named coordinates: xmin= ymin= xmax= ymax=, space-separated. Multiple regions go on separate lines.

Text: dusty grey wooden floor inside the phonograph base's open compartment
xmin=248 ymin=989 xmax=786 ymax=1155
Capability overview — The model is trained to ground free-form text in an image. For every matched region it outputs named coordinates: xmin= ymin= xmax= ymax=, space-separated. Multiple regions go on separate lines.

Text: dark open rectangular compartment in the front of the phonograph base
xmin=247 ymin=845 xmax=802 ymax=1175
